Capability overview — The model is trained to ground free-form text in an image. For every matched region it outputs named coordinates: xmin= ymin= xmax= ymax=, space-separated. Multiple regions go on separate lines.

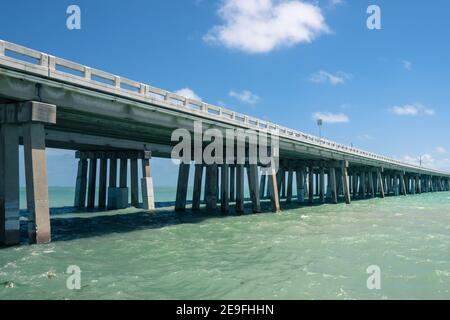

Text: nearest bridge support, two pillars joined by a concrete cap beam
xmin=0 ymin=101 xmax=56 ymax=245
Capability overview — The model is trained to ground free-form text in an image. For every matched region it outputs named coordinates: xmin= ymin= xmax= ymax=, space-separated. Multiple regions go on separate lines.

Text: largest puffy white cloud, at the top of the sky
xmin=203 ymin=0 xmax=329 ymax=54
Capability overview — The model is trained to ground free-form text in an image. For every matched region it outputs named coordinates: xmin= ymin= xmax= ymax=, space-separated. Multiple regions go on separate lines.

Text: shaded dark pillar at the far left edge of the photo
xmin=0 ymin=124 xmax=20 ymax=245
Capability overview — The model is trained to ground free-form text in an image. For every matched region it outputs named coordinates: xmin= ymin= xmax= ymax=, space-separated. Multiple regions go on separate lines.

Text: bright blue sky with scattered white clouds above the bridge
xmin=0 ymin=0 xmax=450 ymax=185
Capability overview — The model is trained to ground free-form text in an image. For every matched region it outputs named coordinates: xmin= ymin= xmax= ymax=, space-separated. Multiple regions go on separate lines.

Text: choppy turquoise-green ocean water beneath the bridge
xmin=0 ymin=188 xmax=450 ymax=299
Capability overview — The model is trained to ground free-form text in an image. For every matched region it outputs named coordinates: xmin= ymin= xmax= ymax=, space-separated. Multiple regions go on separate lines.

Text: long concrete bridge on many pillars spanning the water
xmin=0 ymin=41 xmax=450 ymax=245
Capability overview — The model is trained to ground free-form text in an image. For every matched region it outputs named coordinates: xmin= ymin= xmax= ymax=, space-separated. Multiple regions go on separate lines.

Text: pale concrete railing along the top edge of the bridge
xmin=0 ymin=40 xmax=446 ymax=174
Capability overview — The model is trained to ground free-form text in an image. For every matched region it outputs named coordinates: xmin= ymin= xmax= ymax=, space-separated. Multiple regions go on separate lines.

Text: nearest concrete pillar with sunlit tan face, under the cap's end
xmin=22 ymin=123 xmax=51 ymax=244
